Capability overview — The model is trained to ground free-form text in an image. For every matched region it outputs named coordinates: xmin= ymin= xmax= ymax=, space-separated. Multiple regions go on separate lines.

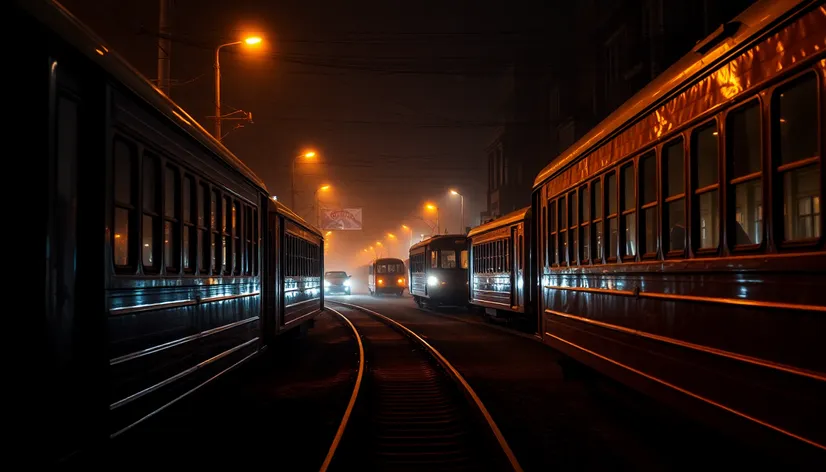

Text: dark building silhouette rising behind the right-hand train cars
xmin=482 ymin=0 xmax=756 ymax=222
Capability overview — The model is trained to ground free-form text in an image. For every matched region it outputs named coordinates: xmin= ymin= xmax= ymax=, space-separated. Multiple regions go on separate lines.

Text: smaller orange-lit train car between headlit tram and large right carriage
xmin=468 ymin=207 xmax=536 ymax=328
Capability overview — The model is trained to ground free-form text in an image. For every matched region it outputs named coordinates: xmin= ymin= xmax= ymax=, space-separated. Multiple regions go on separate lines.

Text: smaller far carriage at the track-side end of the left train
xmin=265 ymin=200 xmax=324 ymax=335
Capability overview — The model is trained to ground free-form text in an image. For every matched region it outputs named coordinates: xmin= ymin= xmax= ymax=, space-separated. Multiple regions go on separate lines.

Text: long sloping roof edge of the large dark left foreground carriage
xmin=20 ymin=0 xmax=269 ymax=194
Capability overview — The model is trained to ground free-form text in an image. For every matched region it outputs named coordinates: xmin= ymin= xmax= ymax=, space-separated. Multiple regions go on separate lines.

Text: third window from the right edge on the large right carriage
xmin=691 ymin=121 xmax=720 ymax=249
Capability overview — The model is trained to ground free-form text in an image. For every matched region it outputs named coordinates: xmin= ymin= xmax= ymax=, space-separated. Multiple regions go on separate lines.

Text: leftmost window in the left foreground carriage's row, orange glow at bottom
xmin=112 ymin=139 xmax=136 ymax=267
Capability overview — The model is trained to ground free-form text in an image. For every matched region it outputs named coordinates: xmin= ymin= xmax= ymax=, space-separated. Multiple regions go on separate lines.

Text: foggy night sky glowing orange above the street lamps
xmin=62 ymin=0 xmax=542 ymax=270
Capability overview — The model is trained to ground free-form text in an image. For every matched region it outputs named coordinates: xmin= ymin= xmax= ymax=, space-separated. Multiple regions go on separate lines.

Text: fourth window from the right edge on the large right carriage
xmin=662 ymin=137 xmax=685 ymax=252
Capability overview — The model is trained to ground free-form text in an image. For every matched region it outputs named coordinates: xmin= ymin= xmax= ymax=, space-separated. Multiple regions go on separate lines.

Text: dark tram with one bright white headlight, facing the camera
xmin=409 ymin=234 xmax=468 ymax=306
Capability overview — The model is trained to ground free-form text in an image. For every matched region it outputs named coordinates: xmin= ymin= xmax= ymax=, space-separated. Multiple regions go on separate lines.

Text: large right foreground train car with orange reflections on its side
xmin=533 ymin=0 xmax=826 ymax=453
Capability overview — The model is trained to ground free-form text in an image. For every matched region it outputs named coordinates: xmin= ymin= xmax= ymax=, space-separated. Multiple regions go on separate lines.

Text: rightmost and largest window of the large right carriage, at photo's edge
xmin=772 ymin=73 xmax=822 ymax=241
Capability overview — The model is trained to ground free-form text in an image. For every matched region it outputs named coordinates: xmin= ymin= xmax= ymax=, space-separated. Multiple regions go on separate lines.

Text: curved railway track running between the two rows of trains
xmin=321 ymin=301 xmax=522 ymax=472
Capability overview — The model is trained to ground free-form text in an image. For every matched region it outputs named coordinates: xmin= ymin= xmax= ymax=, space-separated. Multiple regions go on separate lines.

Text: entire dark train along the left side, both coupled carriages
xmin=20 ymin=0 xmax=323 ymax=462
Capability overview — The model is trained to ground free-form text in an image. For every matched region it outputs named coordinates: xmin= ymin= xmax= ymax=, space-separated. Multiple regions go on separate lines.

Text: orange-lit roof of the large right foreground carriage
xmin=533 ymin=0 xmax=818 ymax=190
